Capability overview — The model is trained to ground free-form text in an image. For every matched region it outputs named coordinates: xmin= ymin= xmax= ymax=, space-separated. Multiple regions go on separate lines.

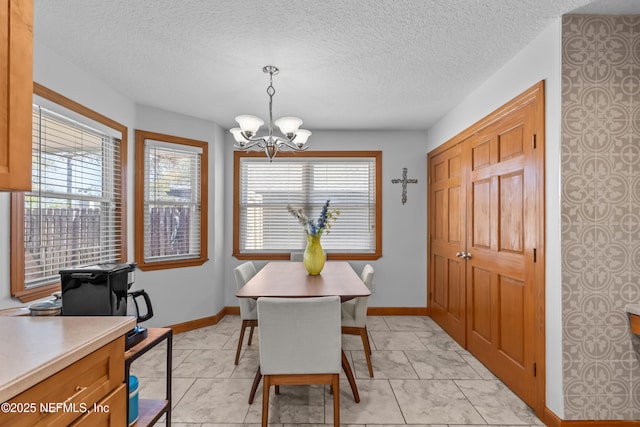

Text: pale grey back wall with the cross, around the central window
xmin=225 ymin=130 xmax=427 ymax=307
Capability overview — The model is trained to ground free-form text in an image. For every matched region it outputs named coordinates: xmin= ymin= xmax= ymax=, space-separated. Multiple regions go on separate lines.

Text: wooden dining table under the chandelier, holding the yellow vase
xmin=236 ymin=261 xmax=371 ymax=403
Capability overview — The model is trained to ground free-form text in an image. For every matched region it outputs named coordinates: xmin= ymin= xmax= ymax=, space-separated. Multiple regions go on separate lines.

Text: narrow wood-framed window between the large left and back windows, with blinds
xmin=135 ymin=130 xmax=208 ymax=270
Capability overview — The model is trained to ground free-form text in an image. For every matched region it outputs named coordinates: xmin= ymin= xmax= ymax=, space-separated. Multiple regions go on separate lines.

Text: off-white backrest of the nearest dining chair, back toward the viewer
xmin=258 ymin=296 xmax=342 ymax=375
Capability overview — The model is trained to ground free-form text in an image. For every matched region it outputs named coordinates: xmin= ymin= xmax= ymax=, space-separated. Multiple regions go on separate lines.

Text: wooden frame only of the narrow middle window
xmin=134 ymin=129 xmax=209 ymax=271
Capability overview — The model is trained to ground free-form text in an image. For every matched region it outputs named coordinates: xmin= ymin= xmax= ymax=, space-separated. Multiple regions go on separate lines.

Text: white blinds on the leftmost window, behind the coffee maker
xmin=24 ymin=105 xmax=122 ymax=289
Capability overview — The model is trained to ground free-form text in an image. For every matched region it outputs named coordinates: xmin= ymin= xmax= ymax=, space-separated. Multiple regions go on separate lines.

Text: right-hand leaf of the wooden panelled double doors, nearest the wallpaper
xmin=463 ymin=104 xmax=537 ymax=406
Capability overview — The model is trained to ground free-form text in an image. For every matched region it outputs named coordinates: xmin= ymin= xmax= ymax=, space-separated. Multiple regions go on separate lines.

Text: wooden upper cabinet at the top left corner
xmin=0 ymin=0 xmax=33 ymax=191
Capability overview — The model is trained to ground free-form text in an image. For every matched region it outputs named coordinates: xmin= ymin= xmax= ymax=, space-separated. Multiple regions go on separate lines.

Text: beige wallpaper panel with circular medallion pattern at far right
xmin=562 ymin=15 xmax=640 ymax=420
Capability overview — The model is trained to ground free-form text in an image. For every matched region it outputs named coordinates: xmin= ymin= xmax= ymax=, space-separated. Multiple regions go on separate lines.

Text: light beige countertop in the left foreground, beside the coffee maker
xmin=0 ymin=316 xmax=136 ymax=403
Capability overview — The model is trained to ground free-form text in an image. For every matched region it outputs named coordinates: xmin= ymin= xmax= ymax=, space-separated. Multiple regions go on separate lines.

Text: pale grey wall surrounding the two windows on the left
xmin=0 ymin=43 xmax=225 ymax=326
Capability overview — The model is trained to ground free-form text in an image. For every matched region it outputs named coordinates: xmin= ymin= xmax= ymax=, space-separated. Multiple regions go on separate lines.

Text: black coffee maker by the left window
xmin=60 ymin=263 xmax=153 ymax=350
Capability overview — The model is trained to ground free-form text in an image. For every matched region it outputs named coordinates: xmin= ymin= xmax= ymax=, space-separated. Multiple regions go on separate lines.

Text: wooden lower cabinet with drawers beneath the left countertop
xmin=0 ymin=337 xmax=128 ymax=427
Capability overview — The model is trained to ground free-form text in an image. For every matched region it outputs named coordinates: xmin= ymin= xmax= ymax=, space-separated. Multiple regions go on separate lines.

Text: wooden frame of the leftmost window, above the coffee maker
xmin=10 ymin=82 xmax=128 ymax=302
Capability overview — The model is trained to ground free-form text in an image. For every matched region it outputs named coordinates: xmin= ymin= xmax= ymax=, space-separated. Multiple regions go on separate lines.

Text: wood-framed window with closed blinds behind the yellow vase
xmin=233 ymin=151 xmax=382 ymax=260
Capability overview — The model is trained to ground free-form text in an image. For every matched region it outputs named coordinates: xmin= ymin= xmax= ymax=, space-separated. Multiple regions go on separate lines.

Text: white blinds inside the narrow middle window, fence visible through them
xmin=144 ymin=139 xmax=202 ymax=263
